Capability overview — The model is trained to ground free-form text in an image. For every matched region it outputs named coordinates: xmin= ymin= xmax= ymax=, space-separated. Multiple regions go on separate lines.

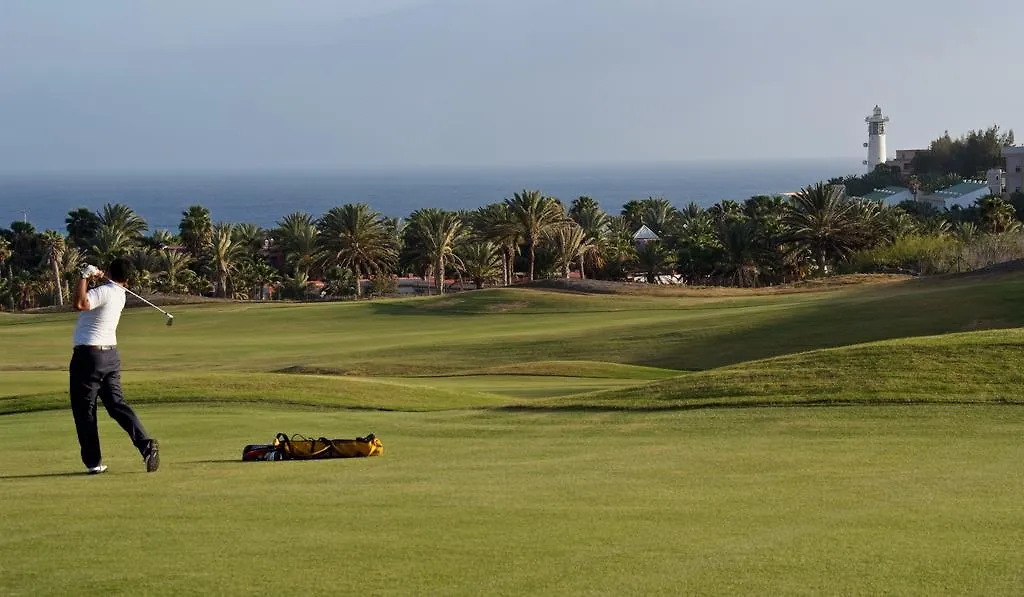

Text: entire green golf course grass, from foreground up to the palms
xmin=0 ymin=272 xmax=1024 ymax=595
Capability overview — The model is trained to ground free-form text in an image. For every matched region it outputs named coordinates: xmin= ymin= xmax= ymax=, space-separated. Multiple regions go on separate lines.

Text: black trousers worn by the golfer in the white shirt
xmin=70 ymin=346 xmax=151 ymax=468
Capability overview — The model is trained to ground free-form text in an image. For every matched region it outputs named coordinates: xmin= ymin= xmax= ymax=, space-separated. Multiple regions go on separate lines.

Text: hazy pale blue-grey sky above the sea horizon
xmin=0 ymin=0 xmax=1024 ymax=173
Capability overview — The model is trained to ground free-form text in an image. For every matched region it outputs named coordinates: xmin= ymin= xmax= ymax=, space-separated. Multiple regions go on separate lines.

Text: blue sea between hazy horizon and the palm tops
xmin=0 ymin=159 xmax=861 ymax=231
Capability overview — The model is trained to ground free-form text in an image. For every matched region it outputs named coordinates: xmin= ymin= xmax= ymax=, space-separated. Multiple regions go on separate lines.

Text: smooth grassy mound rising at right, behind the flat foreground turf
xmin=530 ymin=330 xmax=1024 ymax=410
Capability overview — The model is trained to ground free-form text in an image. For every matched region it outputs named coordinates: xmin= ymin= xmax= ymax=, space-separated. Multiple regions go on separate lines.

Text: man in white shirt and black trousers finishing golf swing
xmin=70 ymin=259 xmax=160 ymax=474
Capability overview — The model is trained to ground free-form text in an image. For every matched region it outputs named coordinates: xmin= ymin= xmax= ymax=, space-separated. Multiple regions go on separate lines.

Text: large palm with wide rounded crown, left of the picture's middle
xmin=317 ymin=203 xmax=398 ymax=297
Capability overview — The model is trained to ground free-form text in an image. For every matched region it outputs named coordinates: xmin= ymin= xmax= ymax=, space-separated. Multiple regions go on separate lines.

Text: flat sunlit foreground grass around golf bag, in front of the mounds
xmin=0 ymin=407 xmax=1024 ymax=595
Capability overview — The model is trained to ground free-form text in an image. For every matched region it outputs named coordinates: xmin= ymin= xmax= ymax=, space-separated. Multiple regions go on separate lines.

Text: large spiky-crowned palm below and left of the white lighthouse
xmin=783 ymin=182 xmax=857 ymax=272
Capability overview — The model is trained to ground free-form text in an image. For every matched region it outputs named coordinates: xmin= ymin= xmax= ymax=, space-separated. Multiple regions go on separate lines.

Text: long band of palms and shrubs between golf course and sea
xmin=0 ymin=182 xmax=1024 ymax=309
